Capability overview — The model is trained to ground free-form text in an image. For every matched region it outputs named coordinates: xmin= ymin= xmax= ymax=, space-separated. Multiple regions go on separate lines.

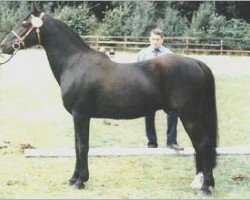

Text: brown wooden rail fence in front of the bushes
xmin=82 ymin=36 xmax=250 ymax=55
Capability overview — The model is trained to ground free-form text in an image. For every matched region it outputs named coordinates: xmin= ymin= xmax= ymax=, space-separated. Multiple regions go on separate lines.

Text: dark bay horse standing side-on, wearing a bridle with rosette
xmin=1 ymin=9 xmax=217 ymax=194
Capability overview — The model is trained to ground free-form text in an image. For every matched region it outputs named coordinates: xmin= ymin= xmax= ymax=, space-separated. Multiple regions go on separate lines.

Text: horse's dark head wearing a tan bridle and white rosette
xmin=1 ymin=8 xmax=44 ymax=54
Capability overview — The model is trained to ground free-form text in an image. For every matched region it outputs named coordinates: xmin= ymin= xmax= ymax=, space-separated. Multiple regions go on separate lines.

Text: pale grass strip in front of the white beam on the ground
xmin=0 ymin=155 xmax=250 ymax=199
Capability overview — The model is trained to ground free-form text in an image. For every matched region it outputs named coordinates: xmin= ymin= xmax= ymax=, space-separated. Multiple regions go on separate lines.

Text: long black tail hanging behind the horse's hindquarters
xmin=198 ymin=61 xmax=218 ymax=166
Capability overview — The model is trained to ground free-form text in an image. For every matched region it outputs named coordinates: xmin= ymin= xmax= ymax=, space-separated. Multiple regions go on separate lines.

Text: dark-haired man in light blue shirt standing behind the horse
xmin=137 ymin=28 xmax=183 ymax=150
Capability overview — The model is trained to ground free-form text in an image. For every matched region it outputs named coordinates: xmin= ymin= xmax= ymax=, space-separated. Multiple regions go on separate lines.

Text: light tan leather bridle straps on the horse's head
xmin=11 ymin=12 xmax=45 ymax=51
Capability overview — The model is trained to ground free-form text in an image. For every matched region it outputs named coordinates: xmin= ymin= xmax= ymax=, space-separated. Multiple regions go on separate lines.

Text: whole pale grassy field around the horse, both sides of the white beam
xmin=0 ymin=50 xmax=250 ymax=199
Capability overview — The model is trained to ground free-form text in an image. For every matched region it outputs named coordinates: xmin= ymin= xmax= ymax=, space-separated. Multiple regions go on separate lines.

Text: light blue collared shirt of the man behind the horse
xmin=137 ymin=46 xmax=173 ymax=62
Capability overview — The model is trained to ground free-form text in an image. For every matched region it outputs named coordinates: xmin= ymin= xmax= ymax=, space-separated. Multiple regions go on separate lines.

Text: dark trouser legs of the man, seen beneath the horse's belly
xmin=145 ymin=111 xmax=178 ymax=144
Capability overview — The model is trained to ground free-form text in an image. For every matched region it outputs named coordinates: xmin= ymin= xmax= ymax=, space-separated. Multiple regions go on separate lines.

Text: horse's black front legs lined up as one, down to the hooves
xmin=69 ymin=112 xmax=90 ymax=189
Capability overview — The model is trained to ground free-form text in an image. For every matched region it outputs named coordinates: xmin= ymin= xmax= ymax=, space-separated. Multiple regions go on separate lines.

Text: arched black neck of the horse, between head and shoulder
xmin=41 ymin=18 xmax=90 ymax=84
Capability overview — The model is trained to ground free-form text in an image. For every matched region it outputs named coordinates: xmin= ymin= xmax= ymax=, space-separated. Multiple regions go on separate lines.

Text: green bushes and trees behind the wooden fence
xmin=0 ymin=1 xmax=250 ymax=49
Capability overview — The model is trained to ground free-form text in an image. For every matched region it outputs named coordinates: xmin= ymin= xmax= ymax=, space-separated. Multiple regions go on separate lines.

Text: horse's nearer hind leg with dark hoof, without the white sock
xmin=180 ymin=116 xmax=216 ymax=195
